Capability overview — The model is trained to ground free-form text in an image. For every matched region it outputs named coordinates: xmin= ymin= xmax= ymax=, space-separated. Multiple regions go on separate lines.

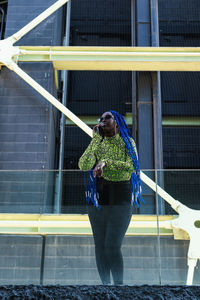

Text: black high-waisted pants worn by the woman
xmin=88 ymin=180 xmax=132 ymax=285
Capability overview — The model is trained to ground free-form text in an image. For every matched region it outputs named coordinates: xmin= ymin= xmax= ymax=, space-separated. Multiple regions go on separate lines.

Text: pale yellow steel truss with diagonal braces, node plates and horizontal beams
xmin=0 ymin=0 xmax=200 ymax=285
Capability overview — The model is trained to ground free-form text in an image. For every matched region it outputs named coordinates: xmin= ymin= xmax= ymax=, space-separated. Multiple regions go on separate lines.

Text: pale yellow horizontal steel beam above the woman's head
xmin=17 ymin=46 xmax=200 ymax=71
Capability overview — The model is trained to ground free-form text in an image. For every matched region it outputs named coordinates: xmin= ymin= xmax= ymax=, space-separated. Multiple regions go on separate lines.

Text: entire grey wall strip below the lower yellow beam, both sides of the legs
xmin=0 ymin=235 xmax=200 ymax=285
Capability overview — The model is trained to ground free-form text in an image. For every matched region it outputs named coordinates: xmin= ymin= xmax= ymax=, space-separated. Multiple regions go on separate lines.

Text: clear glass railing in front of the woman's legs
xmin=0 ymin=170 xmax=200 ymax=285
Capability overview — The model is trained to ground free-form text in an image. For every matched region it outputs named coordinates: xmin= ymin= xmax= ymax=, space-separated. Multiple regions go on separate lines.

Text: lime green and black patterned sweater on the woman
xmin=78 ymin=133 xmax=137 ymax=181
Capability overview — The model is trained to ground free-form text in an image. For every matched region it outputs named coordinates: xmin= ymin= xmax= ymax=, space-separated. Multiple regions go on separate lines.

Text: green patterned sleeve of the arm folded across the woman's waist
xmin=103 ymin=139 xmax=138 ymax=173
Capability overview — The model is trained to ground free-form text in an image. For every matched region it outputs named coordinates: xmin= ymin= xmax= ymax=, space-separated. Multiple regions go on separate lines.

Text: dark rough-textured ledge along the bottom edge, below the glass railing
xmin=0 ymin=285 xmax=200 ymax=300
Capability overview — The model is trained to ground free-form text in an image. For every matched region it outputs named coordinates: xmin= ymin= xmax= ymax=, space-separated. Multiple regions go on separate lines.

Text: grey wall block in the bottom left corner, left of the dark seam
xmin=0 ymin=235 xmax=42 ymax=285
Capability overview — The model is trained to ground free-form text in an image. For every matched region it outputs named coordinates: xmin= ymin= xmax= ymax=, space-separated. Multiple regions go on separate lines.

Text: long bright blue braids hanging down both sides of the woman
xmin=84 ymin=110 xmax=144 ymax=208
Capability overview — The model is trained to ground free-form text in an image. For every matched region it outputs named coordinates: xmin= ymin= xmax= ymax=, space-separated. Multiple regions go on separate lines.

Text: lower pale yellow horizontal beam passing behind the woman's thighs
xmin=0 ymin=214 xmax=174 ymax=235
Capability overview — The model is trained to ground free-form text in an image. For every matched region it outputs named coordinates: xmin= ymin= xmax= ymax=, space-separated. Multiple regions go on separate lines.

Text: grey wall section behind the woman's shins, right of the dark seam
xmin=44 ymin=236 xmax=200 ymax=285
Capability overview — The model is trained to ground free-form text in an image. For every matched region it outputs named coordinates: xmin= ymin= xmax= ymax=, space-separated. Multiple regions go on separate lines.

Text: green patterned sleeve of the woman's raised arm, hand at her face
xmin=78 ymin=133 xmax=101 ymax=171
